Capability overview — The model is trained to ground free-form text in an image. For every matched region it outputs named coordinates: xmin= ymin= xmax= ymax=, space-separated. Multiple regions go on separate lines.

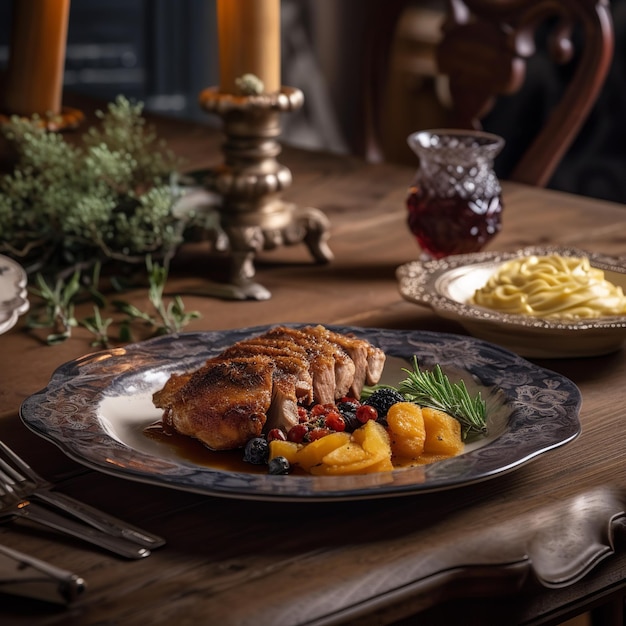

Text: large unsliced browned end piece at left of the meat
xmin=153 ymin=356 xmax=276 ymax=450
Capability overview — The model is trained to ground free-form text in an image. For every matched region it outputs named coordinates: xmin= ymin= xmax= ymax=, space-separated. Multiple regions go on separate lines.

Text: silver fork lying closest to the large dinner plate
xmin=0 ymin=441 xmax=165 ymax=549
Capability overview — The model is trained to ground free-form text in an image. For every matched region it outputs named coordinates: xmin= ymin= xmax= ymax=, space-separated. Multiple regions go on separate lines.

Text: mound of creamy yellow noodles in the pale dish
xmin=470 ymin=254 xmax=626 ymax=319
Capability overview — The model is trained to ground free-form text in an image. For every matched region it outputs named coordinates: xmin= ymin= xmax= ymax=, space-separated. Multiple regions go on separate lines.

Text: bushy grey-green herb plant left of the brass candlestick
xmin=0 ymin=96 xmax=190 ymax=277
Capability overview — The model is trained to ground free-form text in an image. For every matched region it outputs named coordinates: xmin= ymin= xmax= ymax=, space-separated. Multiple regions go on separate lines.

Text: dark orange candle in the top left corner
xmin=0 ymin=0 xmax=70 ymax=117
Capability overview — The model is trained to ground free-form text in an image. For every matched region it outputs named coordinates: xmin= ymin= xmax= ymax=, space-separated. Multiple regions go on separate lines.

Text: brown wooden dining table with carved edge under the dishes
xmin=0 ymin=113 xmax=626 ymax=626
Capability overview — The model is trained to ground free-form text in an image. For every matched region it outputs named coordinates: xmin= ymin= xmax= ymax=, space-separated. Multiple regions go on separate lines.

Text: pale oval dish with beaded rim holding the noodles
xmin=397 ymin=247 xmax=626 ymax=358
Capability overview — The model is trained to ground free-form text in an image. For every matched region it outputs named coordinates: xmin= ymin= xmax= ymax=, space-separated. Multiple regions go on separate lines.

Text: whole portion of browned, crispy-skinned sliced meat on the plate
xmin=153 ymin=326 xmax=385 ymax=450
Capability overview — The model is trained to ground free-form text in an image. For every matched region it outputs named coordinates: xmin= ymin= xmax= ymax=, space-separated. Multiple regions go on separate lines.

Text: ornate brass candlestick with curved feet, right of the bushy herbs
xmin=200 ymin=87 xmax=333 ymax=300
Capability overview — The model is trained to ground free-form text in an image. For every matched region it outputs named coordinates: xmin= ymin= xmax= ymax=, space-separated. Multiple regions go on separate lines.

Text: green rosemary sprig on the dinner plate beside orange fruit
xmin=398 ymin=356 xmax=487 ymax=439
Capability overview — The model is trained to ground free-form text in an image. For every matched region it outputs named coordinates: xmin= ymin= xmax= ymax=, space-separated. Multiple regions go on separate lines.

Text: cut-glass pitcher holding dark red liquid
xmin=407 ymin=129 xmax=504 ymax=259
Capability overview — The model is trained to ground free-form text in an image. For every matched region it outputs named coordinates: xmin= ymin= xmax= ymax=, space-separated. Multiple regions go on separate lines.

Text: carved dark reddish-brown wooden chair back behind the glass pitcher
xmin=364 ymin=0 xmax=613 ymax=187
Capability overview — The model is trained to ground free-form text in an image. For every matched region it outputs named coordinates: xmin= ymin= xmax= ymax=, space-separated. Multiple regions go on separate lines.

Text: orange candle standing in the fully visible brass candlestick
xmin=217 ymin=0 xmax=281 ymax=93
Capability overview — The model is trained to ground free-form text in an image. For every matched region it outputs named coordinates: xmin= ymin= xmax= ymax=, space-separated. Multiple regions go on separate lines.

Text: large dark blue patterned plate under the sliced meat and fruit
xmin=20 ymin=326 xmax=581 ymax=500
